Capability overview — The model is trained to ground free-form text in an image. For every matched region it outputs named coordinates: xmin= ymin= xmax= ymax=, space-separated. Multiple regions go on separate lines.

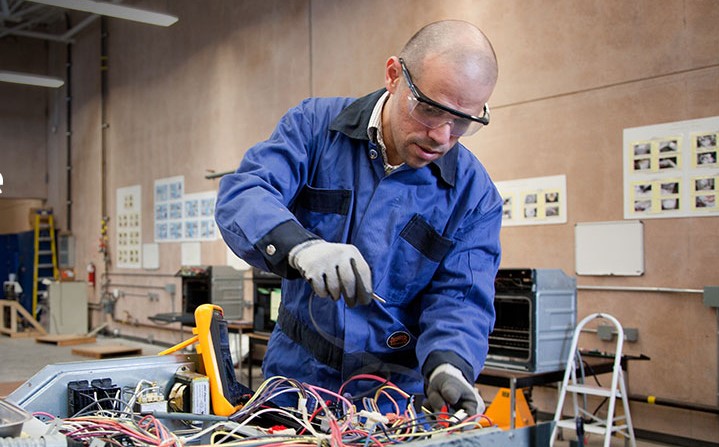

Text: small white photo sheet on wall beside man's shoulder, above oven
xmin=495 ymin=175 xmax=567 ymax=226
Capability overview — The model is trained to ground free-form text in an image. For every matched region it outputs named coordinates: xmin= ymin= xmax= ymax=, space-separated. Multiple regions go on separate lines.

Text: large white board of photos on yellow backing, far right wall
xmin=623 ymin=117 xmax=719 ymax=219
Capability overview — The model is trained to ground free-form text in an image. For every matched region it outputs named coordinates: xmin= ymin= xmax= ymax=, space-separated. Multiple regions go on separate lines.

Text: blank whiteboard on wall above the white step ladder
xmin=574 ymin=220 xmax=644 ymax=276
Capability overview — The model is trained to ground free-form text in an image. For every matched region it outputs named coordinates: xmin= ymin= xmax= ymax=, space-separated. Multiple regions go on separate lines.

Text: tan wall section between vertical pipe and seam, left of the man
xmin=90 ymin=1 xmax=309 ymax=322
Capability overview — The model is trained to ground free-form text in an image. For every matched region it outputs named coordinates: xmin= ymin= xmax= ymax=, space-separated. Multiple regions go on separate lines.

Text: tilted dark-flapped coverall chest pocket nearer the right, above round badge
xmin=378 ymin=214 xmax=453 ymax=304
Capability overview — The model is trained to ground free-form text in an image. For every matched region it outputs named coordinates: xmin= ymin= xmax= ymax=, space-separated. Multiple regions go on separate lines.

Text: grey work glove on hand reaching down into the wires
xmin=427 ymin=363 xmax=485 ymax=416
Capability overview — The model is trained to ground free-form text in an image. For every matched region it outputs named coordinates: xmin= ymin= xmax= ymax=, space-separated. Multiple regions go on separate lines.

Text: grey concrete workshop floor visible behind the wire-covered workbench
xmin=0 ymin=335 xmax=665 ymax=447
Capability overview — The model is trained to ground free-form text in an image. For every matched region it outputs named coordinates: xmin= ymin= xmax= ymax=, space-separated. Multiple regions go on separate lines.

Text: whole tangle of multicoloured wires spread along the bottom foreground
xmin=36 ymin=374 xmax=492 ymax=447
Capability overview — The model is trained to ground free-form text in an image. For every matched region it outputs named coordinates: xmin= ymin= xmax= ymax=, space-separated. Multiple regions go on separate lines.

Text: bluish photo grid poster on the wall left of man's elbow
xmin=154 ymin=176 xmax=217 ymax=242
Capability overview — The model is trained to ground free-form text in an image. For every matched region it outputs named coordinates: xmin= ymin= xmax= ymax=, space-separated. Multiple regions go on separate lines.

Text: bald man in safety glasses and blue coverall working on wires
xmin=216 ymin=21 xmax=502 ymax=414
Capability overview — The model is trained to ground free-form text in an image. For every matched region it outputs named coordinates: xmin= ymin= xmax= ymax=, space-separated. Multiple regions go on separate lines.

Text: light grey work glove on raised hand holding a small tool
xmin=288 ymin=239 xmax=372 ymax=307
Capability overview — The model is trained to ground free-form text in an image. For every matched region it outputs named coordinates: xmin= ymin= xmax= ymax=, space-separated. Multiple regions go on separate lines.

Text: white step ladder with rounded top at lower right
xmin=550 ymin=313 xmax=637 ymax=447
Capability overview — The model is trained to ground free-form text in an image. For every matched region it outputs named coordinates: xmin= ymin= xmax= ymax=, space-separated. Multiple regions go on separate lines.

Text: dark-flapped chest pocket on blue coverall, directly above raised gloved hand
xmin=294 ymin=185 xmax=352 ymax=242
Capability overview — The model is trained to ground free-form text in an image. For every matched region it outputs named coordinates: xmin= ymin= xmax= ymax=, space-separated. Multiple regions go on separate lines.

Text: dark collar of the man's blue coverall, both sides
xmin=330 ymin=89 xmax=459 ymax=186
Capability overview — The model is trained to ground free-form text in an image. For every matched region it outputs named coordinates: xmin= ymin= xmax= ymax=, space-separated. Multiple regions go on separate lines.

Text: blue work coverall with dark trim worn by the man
xmin=216 ymin=90 xmax=502 ymax=404
